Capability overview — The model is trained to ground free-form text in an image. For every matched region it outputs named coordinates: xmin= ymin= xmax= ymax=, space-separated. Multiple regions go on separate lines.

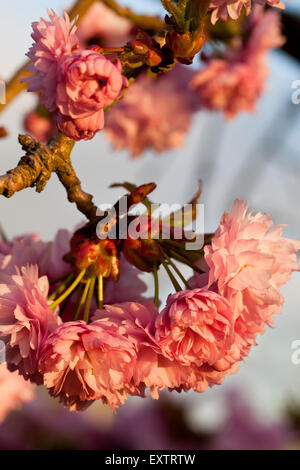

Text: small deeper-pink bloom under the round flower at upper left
xmin=57 ymin=109 xmax=104 ymax=141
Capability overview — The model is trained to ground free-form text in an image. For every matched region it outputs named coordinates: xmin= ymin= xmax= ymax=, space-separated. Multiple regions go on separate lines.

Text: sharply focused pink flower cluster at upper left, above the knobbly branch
xmin=26 ymin=11 xmax=128 ymax=140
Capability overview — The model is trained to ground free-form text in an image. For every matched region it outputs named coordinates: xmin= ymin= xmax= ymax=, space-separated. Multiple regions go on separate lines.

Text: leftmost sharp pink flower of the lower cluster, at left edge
xmin=0 ymin=265 xmax=60 ymax=377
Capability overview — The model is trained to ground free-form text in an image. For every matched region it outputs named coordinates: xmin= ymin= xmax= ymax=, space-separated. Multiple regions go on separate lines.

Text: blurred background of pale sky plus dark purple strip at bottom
xmin=0 ymin=0 xmax=300 ymax=449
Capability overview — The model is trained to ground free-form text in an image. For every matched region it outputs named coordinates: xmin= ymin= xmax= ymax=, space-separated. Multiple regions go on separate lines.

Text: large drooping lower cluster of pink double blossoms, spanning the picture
xmin=0 ymin=200 xmax=300 ymax=410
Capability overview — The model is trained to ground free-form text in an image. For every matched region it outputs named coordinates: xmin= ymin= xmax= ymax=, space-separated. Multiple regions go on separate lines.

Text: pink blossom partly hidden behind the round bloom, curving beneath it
xmin=93 ymin=301 xmax=238 ymax=399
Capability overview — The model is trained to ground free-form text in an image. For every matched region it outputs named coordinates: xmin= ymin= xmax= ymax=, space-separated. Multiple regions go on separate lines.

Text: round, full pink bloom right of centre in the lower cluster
xmin=155 ymin=289 xmax=234 ymax=366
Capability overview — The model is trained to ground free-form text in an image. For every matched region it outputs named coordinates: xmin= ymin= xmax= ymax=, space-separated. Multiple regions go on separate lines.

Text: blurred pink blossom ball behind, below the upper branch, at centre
xmin=105 ymin=66 xmax=197 ymax=157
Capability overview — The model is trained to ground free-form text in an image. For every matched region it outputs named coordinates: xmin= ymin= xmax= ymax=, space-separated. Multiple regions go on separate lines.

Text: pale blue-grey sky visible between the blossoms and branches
xmin=0 ymin=0 xmax=300 ymax=427
